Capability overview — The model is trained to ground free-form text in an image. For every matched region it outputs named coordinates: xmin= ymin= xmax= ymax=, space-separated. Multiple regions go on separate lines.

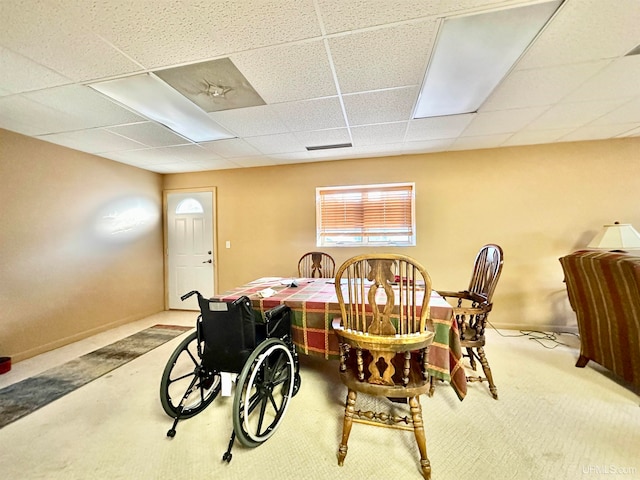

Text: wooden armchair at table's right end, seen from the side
xmin=438 ymin=244 xmax=504 ymax=400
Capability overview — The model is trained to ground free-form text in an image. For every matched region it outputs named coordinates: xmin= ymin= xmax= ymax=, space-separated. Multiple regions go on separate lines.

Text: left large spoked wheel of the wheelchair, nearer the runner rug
xmin=160 ymin=332 xmax=220 ymax=418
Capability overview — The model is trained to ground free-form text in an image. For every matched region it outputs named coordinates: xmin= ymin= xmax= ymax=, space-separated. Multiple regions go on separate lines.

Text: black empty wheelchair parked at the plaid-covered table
xmin=160 ymin=290 xmax=301 ymax=463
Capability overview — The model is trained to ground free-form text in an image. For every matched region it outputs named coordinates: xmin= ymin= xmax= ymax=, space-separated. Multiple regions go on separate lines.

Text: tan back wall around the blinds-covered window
xmin=164 ymin=138 xmax=640 ymax=330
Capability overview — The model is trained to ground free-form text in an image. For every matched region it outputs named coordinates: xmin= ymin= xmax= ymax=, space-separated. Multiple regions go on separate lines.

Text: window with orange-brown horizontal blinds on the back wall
xmin=316 ymin=183 xmax=416 ymax=247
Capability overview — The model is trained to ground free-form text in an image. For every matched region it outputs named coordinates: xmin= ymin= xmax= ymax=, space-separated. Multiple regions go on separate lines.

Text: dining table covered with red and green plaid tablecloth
xmin=213 ymin=277 xmax=467 ymax=400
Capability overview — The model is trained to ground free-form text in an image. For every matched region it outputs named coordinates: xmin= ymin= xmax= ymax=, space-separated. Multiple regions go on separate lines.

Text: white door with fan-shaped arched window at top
xmin=167 ymin=192 xmax=215 ymax=310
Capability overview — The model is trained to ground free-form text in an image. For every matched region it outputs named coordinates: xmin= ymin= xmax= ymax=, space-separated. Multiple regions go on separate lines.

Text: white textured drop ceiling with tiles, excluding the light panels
xmin=0 ymin=0 xmax=640 ymax=173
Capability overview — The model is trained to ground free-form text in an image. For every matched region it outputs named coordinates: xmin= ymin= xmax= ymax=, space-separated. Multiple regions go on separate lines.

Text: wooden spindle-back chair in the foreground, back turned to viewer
xmin=333 ymin=254 xmax=434 ymax=479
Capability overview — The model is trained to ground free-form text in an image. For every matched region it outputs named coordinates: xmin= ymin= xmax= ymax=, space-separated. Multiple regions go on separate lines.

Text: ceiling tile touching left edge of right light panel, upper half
xmin=329 ymin=20 xmax=436 ymax=94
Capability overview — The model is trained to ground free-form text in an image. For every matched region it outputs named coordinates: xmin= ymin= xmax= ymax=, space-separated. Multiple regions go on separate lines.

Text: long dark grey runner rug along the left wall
xmin=0 ymin=325 xmax=193 ymax=428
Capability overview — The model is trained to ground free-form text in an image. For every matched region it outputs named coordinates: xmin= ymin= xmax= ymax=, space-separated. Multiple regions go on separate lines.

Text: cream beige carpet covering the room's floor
xmin=0 ymin=312 xmax=640 ymax=480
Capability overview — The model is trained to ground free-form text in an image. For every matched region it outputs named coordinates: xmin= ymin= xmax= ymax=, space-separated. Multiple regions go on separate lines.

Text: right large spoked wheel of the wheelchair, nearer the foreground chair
xmin=233 ymin=338 xmax=295 ymax=448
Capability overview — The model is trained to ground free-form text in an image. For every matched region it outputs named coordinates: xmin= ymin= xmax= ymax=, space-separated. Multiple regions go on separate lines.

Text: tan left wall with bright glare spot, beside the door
xmin=0 ymin=129 xmax=164 ymax=361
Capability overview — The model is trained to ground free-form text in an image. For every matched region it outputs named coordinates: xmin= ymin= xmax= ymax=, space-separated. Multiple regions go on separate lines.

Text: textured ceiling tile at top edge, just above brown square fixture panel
xmin=91 ymin=0 xmax=320 ymax=68
